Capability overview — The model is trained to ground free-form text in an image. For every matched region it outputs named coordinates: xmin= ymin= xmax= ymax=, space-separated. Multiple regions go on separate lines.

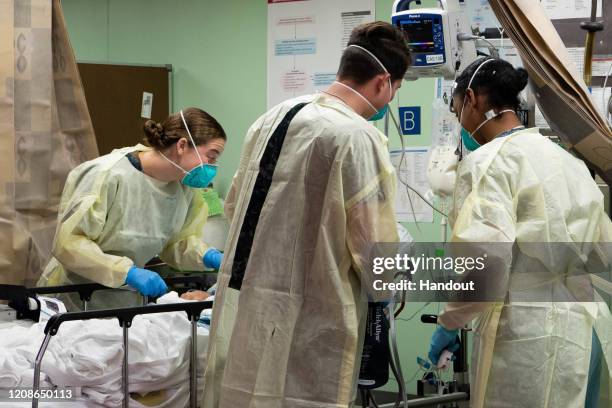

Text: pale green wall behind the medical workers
xmin=62 ymin=0 xmax=450 ymax=391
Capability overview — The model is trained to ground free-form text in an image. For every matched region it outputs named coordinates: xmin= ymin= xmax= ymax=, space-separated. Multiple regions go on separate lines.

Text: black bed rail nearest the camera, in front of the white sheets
xmin=32 ymin=301 xmax=213 ymax=408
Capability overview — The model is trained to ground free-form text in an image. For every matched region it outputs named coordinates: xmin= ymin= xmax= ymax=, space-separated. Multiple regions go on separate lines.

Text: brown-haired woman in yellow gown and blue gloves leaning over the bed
xmin=39 ymin=108 xmax=226 ymax=309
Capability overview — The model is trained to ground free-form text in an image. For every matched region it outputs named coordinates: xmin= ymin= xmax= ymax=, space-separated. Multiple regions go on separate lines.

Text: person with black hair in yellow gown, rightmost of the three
xmin=429 ymin=58 xmax=612 ymax=408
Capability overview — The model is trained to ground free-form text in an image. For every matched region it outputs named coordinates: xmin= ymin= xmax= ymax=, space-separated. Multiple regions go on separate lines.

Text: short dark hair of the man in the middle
xmin=338 ymin=21 xmax=410 ymax=84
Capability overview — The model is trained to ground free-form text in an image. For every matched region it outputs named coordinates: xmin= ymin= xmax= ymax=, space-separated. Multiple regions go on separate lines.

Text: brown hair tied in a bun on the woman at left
xmin=142 ymin=108 xmax=227 ymax=150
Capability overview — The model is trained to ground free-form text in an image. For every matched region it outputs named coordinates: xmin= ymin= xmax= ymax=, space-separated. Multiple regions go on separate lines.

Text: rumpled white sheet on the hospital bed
xmin=0 ymin=292 xmax=208 ymax=408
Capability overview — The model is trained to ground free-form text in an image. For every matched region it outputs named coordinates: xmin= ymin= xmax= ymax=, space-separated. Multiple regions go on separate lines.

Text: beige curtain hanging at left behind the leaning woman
xmin=0 ymin=0 xmax=98 ymax=285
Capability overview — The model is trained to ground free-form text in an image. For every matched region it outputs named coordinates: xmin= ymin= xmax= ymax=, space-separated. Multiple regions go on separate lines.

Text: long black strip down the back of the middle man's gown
xmin=229 ymin=103 xmax=306 ymax=290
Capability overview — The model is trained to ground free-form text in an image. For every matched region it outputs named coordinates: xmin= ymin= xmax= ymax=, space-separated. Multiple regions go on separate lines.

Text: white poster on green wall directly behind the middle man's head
xmin=267 ymin=0 xmax=375 ymax=108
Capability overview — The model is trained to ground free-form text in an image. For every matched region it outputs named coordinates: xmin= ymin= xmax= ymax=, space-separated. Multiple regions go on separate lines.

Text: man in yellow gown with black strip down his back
xmin=203 ymin=22 xmax=410 ymax=408
